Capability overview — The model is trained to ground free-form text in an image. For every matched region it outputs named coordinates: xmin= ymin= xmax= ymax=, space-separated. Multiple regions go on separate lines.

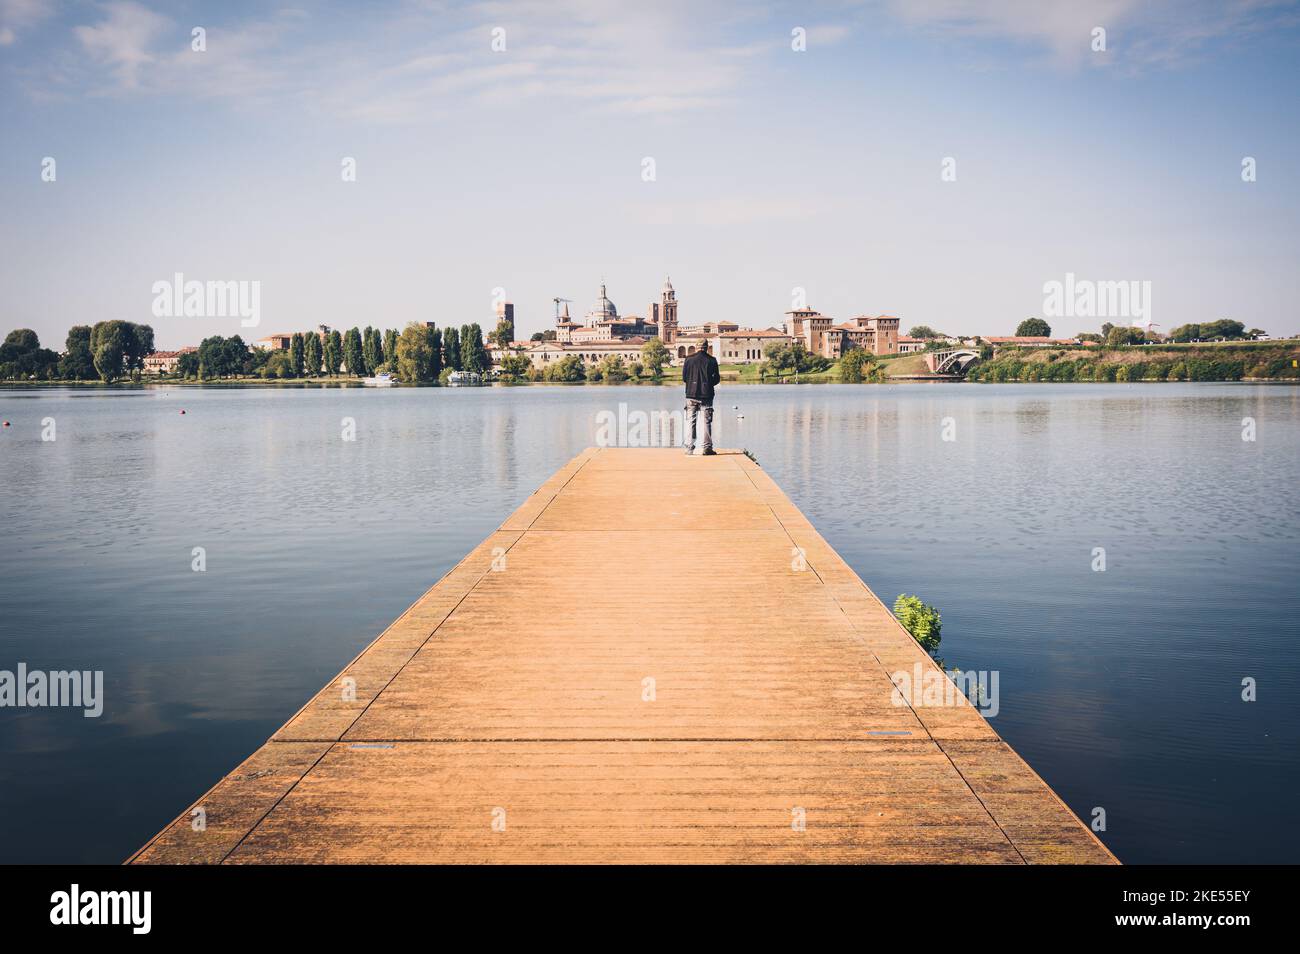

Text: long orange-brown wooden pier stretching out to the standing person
xmin=130 ymin=448 xmax=1115 ymax=864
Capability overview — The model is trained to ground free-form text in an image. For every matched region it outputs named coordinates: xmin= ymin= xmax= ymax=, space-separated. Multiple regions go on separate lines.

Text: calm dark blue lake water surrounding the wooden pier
xmin=0 ymin=385 xmax=1300 ymax=863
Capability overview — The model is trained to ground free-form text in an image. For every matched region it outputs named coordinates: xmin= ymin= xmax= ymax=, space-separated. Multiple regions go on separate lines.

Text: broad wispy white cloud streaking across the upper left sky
xmin=32 ymin=0 xmax=780 ymax=122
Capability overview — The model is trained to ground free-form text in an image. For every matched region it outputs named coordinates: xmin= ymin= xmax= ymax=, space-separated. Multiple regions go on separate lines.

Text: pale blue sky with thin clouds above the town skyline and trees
xmin=0 ymin=0 xmax=1300 ymax=350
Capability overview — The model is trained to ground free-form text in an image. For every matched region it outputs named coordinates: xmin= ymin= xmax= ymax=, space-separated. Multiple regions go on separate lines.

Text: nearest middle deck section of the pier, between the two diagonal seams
xmin=223 ymin=740 xmax=1019 ymax=863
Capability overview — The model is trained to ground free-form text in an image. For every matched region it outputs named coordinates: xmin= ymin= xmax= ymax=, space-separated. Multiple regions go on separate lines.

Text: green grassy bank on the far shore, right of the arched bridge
xmin=967 ymin=342 xmax=1300 ymax=382
